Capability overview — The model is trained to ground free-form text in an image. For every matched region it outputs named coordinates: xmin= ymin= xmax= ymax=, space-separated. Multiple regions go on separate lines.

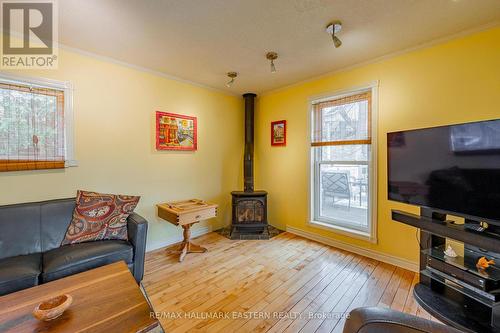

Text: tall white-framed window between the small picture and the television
xmin=311 ymin=89 xmax=375 ymax=238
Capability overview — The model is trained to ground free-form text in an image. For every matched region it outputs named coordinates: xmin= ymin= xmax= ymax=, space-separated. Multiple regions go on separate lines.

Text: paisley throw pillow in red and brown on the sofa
xmin=61 ymin=191 xmax=140 ymax=245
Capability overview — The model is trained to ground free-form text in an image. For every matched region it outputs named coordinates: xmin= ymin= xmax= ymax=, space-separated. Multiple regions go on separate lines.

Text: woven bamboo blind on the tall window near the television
xmin=311 ymin=92 xmax=371 ymax=147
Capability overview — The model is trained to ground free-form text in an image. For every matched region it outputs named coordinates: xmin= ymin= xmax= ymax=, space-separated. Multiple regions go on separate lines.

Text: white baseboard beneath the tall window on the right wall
xmin=286 ymin=226 xmax=419 ymax=272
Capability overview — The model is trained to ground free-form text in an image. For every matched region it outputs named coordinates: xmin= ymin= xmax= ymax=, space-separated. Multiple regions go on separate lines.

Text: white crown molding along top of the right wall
xmin=259 ymin=21 xmax=500 ymax=96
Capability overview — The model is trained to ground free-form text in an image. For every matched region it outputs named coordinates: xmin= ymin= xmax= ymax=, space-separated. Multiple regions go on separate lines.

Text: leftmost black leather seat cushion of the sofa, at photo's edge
xmin=0 ymin=253 xmax=42 ymax=296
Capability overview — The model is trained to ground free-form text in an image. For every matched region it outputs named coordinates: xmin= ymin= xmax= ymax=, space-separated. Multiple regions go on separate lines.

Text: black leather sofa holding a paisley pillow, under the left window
xmin=0 ymin=198 xmax=148 ymax=296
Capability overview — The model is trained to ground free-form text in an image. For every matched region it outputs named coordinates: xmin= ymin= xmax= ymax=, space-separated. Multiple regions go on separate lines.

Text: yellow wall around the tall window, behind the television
xmin=256 ymin=27 xmax=500 ymax=262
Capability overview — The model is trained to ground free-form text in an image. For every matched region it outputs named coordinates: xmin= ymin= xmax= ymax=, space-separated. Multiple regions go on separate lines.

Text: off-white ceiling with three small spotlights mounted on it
xmin=59 ymin=0 xmax=500 ymax=93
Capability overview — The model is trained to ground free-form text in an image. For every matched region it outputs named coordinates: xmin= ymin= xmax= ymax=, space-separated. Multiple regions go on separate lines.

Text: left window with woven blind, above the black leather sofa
xmin=0 ymin=77 xmax=72 ymax=171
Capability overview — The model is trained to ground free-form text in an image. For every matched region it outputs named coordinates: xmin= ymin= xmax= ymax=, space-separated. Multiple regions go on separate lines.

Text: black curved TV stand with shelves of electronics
xmin=392 ymin=208 xmax=500 ymax=333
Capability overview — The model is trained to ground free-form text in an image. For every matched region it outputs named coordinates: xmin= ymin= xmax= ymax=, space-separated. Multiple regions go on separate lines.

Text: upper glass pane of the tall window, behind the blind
xmin=321 ymin=100 xmax=369 ymax=142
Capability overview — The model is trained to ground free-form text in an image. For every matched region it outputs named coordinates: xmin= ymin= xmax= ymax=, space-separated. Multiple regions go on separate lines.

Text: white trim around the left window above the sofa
xmin=0 ymin=73 xmax=78 ymax=168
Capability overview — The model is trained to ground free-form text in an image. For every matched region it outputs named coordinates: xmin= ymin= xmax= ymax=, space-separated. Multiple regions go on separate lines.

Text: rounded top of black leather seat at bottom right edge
xmin=343 ymin=307 xmax=463 ymax=333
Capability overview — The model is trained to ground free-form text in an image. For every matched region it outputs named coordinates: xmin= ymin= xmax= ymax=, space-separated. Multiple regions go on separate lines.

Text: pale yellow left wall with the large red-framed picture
xmin=0 ymin=49 xmax=244 ymax=248
